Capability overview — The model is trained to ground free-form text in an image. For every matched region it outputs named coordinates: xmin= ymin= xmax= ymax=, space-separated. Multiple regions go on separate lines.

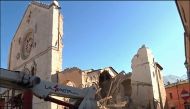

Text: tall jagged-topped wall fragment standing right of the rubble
xmin=131 ymin=45 xmax=166 ymax=109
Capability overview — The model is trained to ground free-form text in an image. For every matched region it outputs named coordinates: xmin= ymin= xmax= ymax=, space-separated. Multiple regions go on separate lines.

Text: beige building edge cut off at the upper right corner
xmin=176 ymin=0 xmax=190 ymax=80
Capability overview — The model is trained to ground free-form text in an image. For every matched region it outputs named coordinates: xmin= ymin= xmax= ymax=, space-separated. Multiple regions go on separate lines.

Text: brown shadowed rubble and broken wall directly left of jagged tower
xmin=97 ymin=72 xmax=132 ymax=109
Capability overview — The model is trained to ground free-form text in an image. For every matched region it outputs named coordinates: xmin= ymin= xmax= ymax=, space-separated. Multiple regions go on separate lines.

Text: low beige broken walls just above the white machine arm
xmin=53 ymin=67 xmax=118 ymax=88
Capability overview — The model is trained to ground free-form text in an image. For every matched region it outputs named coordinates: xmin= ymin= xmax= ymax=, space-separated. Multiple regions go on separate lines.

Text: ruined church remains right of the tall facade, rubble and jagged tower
xmin=52 ymin=45 xmax=166 ymax=109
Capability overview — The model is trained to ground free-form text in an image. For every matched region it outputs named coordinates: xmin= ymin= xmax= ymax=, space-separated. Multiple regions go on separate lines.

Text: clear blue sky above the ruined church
xmin=1 ymin=1 xmax=186 ymax=76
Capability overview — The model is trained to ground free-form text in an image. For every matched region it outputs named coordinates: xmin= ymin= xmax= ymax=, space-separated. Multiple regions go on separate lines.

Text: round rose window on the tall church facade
xmin=21 ymin=31 xmax=34 ymax=60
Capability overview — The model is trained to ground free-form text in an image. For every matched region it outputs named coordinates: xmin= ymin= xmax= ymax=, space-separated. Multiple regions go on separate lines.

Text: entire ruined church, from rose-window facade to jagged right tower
xmin=0 ymin=1 xmax=165 ymax=109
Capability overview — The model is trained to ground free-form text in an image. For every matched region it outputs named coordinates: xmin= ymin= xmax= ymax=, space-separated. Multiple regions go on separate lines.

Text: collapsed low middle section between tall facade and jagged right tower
xmin=53 ymin=67 xmax=132 ymax=109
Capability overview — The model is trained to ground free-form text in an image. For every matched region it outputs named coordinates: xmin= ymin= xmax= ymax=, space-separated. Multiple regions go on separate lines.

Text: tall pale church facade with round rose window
xmin=8 ymin=1 xmax=63 ymax=109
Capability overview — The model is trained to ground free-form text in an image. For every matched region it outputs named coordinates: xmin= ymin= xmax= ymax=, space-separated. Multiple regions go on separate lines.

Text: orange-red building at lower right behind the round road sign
xmin=165 ymin=80 xmax=190 ymax=109
